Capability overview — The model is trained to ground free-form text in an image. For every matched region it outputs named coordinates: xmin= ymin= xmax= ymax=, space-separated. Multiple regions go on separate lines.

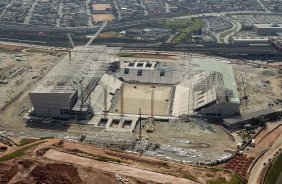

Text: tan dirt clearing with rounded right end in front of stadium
xmin=140 ymin=121 xmax=236 ymax=163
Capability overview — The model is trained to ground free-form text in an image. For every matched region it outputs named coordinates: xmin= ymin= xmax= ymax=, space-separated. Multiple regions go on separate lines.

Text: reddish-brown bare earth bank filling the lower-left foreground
xmin=0 ymin=139 xmax=238 ymax=184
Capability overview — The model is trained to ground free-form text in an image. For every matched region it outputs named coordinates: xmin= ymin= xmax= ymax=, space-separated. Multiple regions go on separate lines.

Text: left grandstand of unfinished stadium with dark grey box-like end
xmin=29 ymin=46 xmax=119 ymax=119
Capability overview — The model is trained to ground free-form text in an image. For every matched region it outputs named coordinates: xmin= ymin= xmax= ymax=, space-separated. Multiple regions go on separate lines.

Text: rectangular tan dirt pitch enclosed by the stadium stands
xmin=114 ymin=84 xmax=172 ymax=116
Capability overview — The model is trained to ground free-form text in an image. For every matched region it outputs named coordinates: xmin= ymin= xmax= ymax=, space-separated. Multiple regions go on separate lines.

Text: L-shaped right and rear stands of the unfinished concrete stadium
xmin=117 ymin=58 xmax=240 ymax=118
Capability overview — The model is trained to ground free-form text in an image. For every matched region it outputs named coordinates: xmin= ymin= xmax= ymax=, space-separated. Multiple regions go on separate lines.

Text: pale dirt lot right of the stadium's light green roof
xmin=232 ymin=65 xmax=282 ymax=113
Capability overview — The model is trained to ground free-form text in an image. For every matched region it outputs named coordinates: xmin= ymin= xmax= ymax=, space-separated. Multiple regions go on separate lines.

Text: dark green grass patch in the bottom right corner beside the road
xmin=265 ymin=153 xmax=282 ymax=184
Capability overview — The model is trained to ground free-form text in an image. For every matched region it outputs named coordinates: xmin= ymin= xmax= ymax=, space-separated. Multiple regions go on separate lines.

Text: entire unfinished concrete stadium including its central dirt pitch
xmin=29 ymin=46 xmax=240 ymax=126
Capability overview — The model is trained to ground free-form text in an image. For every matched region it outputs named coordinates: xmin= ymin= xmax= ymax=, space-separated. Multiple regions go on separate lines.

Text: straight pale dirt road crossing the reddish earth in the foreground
xmin=45 ymin=150 xmax=197 ymax=184
